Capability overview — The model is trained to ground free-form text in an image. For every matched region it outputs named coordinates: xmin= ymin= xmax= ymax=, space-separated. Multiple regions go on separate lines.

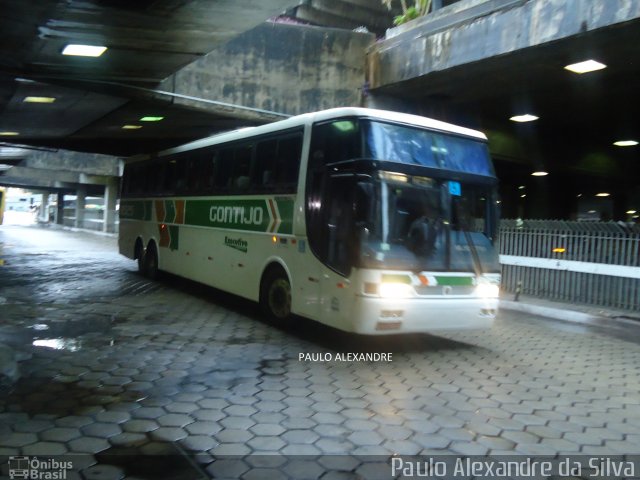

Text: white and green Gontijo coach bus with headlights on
xmin=119 ymin=108 xmax=500 ymax=334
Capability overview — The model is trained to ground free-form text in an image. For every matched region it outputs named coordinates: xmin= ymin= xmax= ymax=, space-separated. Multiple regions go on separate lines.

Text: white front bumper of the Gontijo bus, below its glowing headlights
xmin=348 ymin=296 xmax=498 ymax=335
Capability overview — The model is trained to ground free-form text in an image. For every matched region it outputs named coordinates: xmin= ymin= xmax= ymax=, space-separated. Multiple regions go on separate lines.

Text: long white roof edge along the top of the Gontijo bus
xmin=128 ymin=107 xmax=487 ymax=161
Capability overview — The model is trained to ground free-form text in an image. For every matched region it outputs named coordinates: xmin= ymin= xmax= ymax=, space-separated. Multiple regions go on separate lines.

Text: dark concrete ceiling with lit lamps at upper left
xmin=0 ymin=0 xmax=296 ymax=163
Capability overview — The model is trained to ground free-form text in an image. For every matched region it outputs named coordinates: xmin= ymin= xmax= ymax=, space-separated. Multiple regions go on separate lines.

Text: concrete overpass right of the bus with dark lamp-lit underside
xmin=368 ymin=0 xmax=640 ymax=219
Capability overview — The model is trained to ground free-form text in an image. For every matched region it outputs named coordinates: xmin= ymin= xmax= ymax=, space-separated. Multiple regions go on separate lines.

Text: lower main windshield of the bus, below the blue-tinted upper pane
xmin=356 ymin=172 xmax=500 ymax=274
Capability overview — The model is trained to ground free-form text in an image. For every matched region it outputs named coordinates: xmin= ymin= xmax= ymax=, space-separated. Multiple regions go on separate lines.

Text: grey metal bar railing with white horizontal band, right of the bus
xmin=498 ymin=220 xmax=640 ymax=311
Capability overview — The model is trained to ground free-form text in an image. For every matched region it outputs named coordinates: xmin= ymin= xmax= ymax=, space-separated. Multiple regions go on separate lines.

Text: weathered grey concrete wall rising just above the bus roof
xmin=162 ymin=22 xmax=375 ymax=115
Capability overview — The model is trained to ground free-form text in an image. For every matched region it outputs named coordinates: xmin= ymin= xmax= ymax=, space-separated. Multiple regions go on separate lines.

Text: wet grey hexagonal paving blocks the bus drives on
xmin=0 ymin=226 xmax=640 ymax=480
